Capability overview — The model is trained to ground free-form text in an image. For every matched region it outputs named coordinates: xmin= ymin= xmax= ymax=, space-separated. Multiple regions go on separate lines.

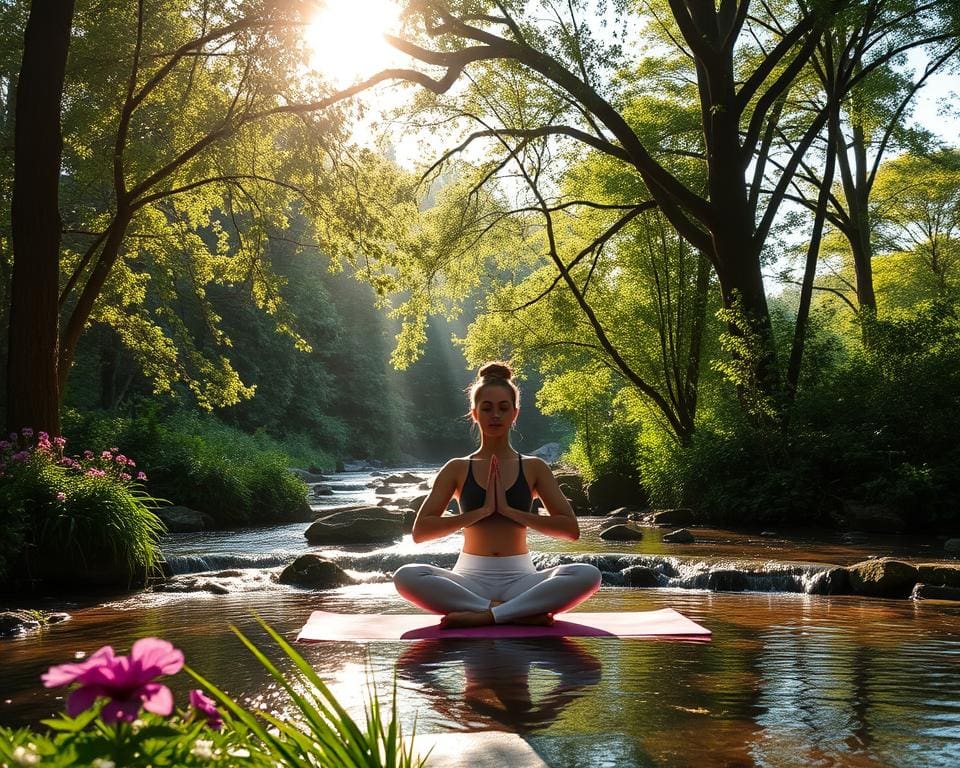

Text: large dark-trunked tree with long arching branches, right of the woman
xmin=372 ymin=0 xmax=860 ymax=420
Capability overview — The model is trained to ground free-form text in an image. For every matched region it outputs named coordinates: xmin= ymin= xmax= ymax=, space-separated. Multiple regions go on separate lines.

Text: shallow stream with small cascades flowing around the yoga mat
xmin=0 ymin=468 xmax=960 ymax=768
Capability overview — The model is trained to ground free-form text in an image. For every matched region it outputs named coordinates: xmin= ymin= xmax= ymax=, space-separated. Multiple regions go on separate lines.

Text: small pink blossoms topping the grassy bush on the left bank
xmin=0 ymin=427 xmax=147 ymax=488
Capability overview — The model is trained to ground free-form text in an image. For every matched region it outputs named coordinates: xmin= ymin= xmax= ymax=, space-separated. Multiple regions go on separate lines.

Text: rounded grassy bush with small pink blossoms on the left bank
xmin=0 ymin=428 xmax=163 ymax=586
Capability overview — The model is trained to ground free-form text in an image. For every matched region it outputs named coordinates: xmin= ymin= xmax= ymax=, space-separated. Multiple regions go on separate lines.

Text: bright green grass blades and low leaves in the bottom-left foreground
xmin=0 ymin=621 xmax=426 ymax=768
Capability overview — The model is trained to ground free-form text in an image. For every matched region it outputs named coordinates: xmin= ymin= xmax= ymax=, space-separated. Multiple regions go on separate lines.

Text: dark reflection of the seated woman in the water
xmin=397 ymin=637 xmax=601 ymax=733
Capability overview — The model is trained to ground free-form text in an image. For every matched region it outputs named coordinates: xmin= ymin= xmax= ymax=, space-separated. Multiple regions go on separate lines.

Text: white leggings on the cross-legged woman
xmin=393 ymin=552 xmax=601 ymax=624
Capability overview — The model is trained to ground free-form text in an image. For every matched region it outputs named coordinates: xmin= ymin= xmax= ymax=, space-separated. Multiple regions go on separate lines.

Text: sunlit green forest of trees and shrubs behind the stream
xmin=0 ymin=0 xmax=960 ymax=592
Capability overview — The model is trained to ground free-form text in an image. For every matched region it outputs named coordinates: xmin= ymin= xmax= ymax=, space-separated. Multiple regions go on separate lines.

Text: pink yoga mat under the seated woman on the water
xmin=297 ymin=608 xmax=710 ymax=642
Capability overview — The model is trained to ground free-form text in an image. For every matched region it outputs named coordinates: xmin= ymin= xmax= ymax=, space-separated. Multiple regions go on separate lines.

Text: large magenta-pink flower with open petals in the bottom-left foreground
xmin=41 ymin=637 xmax=183 ymax=723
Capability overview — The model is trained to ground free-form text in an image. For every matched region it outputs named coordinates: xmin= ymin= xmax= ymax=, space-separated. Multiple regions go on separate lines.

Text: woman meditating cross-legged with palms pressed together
xmin=393 ymin=363 xmax=600 ymax=628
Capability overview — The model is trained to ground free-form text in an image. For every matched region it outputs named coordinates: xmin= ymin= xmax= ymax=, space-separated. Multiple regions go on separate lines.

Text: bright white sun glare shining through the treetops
xmin=305 ymin=0 xmax=401 ymax=86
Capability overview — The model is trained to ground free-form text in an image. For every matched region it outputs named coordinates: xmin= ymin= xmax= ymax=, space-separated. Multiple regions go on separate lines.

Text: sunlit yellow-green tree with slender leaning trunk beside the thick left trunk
xmin=8 ymin=0 xmax=416 ymax=436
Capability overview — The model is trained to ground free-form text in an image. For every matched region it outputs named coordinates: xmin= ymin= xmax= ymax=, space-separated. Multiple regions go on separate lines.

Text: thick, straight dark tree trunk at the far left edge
xmin=7 ymin=0 xmax=74 ymax=434
